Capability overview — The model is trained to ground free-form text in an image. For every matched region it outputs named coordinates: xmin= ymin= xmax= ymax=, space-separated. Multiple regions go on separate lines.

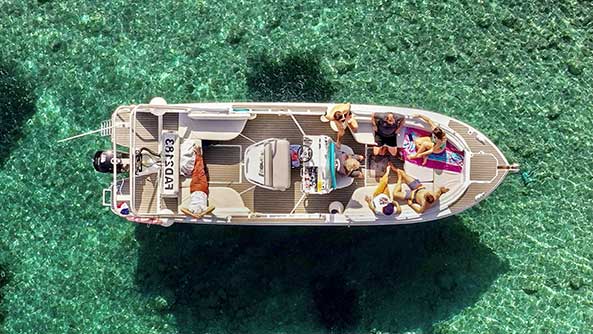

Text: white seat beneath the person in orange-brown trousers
xmin=179 ymin=184 xmax=251 ymax=218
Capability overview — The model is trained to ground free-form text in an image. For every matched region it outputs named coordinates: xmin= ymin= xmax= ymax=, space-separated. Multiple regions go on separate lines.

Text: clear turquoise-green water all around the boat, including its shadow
xmin=0 ymin=0 xmax=593 ymax=334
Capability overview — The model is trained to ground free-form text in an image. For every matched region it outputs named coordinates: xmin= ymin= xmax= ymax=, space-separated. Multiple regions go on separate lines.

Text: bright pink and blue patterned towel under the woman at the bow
xmin=401 ymin=128 xmax=464 ymax=173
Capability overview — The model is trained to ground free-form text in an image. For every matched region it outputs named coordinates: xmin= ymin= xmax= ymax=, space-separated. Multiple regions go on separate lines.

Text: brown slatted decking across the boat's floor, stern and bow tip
xmin=120 ymin=107 xmax=507 ymax=222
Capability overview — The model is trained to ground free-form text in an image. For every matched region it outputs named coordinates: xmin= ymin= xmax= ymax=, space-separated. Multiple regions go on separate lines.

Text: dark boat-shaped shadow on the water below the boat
xmin=136 ymin=217 xmax=508 ymax=333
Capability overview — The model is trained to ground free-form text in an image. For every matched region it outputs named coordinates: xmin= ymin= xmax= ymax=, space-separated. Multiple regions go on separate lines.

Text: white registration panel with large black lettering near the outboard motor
xmin=162 ymin=131 xmax=179 ymax=197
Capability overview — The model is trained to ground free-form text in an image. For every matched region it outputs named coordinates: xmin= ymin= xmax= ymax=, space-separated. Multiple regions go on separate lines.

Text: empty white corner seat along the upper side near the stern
xmin=179 ymin=113 xmax=250 ymax=141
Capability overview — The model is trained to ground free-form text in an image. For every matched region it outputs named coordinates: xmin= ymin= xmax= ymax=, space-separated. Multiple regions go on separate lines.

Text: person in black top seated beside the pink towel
xmin=371 ymin=112 xmax=405 ymax=156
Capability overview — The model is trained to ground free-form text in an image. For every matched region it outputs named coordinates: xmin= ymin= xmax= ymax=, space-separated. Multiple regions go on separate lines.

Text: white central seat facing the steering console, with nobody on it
xmin=244 ymin=138 xmax=291 ymax=191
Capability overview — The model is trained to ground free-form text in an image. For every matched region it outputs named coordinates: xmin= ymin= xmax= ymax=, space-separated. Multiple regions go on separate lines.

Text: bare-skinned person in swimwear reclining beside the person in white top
xmin=391 ymin=166 xmax=449 ymax=213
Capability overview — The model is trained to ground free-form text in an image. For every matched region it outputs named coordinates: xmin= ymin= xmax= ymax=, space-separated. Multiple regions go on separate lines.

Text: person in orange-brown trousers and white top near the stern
xmin=181 ymin=146 xmax=214 ymax=219
